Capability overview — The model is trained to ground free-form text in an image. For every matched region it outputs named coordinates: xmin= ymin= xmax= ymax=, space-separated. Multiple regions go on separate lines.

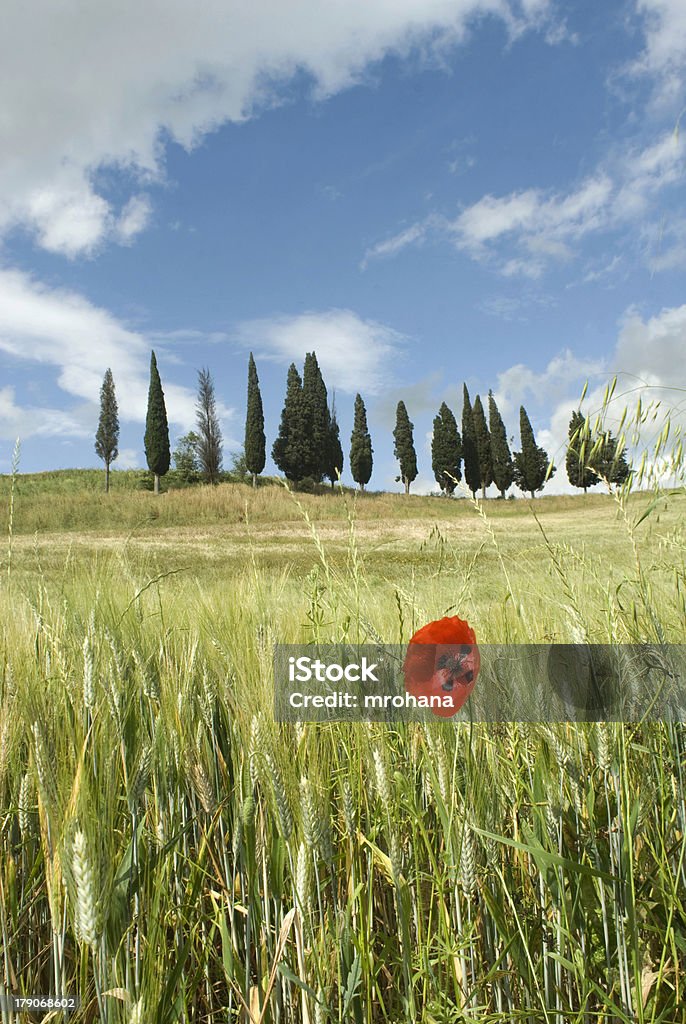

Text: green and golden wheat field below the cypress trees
xmin=0 ymin=452 xmax=686 ymax=1024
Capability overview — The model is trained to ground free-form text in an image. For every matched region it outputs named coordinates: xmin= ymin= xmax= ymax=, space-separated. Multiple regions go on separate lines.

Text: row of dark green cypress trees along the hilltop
xmin=95 ymin=352 xmax=630 ymax=498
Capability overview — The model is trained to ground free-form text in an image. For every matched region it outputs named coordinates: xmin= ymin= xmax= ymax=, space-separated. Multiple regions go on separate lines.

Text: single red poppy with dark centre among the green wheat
xmin=402 ymin=615 xmax=481 ymax=718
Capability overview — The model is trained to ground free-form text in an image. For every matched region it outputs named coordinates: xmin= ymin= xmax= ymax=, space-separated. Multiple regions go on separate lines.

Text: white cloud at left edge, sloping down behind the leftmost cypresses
xmin=0 ymin=270 xmax=225 ymax=433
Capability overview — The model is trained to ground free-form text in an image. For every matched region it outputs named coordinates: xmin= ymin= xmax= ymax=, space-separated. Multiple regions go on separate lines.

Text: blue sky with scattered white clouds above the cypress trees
xmin=0 ymin=0 xmax=686 ymax=490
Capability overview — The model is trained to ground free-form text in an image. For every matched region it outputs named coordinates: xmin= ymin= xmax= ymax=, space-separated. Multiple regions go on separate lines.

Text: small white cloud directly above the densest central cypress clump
xmin=237 ymin=309 xmax=402 ymax=394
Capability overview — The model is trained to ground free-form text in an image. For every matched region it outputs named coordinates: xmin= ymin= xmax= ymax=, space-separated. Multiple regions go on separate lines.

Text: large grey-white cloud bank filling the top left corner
xmin=0 ymin=0 xmax=549 ymax=256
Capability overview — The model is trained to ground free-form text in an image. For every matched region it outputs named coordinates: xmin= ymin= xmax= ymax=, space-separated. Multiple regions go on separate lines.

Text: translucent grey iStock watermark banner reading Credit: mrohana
xmin=273 ymin=644 xmax=686 ymax=722
